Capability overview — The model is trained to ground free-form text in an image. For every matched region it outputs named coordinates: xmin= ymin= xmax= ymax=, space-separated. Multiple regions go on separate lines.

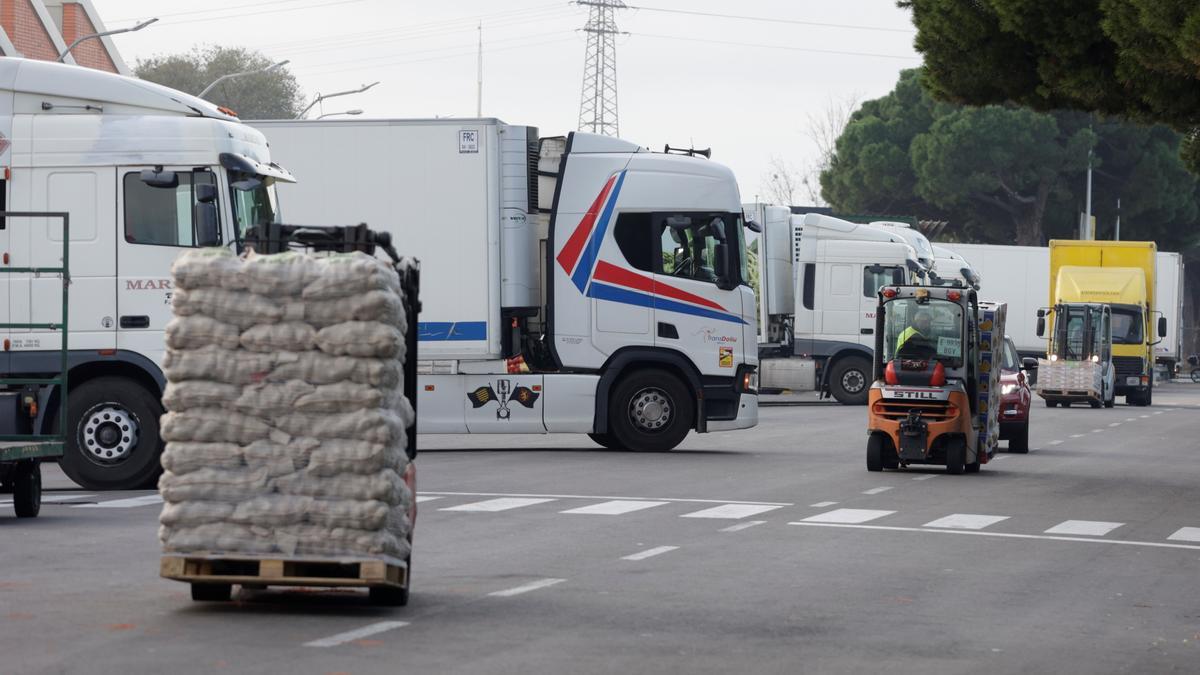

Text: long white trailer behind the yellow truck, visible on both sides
xmin=940 ymin=244 xmax=1184 ymax=372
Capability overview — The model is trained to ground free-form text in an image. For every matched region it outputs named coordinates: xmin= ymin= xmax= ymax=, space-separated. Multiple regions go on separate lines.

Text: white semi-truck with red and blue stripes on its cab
xmin=253 ymin=119 xmax=758 ymax=450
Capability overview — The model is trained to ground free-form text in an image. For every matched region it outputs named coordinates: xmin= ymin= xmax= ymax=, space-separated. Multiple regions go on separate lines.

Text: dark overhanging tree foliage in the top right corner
xmin=899 ymin=0 xmax=1200 ymax=173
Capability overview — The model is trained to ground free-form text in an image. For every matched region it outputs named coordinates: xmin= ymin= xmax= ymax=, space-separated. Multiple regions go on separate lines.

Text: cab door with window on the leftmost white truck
xmin=116 ymin=166 xmax=221 ymax=363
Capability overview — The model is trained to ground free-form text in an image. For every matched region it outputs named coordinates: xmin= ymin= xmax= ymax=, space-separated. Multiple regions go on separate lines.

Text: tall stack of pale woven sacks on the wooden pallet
xmin=158 ymin=249 xmax=414 ymax=560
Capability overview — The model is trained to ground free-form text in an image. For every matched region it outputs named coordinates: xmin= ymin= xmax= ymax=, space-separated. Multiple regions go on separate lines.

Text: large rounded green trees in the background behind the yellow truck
xmin=821 ymin=70 xmax=1200 ymax=250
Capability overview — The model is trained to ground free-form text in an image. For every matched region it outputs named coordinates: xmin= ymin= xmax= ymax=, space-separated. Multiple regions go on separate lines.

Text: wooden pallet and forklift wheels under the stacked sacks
xmin=160 ymin=554 xmax=408 ymax=607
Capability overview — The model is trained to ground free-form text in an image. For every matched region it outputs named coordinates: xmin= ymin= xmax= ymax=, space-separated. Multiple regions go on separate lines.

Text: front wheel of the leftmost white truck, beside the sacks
xmin=53 ymin=377 xmax=163 ymax=490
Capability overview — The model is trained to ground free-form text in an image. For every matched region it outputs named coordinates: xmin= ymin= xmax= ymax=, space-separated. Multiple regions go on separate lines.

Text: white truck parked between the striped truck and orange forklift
xmin=760 ymin=214 xmax=928 ymax=405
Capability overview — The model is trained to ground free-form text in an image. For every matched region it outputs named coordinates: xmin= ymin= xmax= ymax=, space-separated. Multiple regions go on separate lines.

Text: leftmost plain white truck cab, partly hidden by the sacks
xmin=0 ymin=58 xmax=292 ymax=489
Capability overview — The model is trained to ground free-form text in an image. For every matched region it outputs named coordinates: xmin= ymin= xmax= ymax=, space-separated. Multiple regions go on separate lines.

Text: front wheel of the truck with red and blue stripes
xmin=608 ymin=368 xmax=696 ymax=453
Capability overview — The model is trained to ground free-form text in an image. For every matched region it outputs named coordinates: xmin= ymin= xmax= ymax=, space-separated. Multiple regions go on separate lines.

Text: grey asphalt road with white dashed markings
xmin=0 ymin=384 xmax=1200 ymax=675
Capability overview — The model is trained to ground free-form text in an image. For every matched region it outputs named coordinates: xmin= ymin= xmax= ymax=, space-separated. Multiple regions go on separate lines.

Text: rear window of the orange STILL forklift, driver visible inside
xmin=883 ymin=298 xmax=964 ymax=368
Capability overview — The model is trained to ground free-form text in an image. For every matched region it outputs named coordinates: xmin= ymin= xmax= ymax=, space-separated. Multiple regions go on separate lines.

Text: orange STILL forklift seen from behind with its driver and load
xmin=866 ymin=286 xmax=1006 ymax=474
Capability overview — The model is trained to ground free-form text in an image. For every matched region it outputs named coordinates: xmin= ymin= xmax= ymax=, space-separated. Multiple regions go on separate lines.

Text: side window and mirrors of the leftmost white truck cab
xmin=124 ymin=171 xmax=216 ymax=246
